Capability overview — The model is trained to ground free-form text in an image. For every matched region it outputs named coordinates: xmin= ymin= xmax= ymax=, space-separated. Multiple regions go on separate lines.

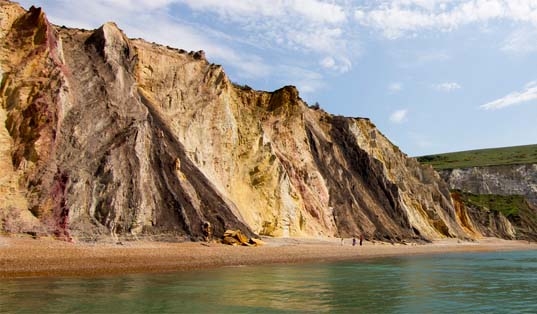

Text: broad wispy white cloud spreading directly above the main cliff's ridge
xmin=20 ymin=0 xmax=359 ymax=92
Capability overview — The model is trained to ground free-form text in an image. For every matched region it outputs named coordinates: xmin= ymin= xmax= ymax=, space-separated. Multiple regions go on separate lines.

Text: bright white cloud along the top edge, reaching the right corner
xmin=354 ymin=0 xmax=537 ymax=39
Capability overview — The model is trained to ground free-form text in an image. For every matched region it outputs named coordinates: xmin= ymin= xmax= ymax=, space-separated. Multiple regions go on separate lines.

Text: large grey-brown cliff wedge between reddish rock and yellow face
xmin=53 ymin=18 xmax=252 ymax=240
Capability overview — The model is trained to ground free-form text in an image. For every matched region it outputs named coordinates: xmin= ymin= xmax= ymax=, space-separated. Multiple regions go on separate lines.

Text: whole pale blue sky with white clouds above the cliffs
xmin=14 ymin=0 xmax=537 ymax=156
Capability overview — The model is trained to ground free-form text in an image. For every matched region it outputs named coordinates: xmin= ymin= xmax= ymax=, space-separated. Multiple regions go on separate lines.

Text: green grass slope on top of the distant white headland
xmin=417 ymin=145 xmax=537 ymax=170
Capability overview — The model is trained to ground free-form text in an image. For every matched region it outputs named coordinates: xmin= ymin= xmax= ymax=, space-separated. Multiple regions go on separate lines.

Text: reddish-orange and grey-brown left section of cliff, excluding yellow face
xmin=1 ymin=2 xmax=250 ymax=239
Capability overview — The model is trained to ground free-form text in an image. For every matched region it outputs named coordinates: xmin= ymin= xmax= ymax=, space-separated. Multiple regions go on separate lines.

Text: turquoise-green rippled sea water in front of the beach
xmin=0 ymin=251 xmax=537 ymax=313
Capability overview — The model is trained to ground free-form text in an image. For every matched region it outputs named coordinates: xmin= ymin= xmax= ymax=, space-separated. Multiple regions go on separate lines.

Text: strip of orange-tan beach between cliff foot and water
xmin=0 ymin=235 xmax=537 ymax=278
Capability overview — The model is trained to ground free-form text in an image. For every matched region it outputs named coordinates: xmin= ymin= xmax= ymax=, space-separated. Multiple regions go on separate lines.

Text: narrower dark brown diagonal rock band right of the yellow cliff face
xmin=307 ymin=117 xmax=416 ymax=241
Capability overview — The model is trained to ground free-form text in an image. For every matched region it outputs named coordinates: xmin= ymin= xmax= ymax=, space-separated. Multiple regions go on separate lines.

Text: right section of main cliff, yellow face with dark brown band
xmin=133 ymin=36 xmax=474 ymax=240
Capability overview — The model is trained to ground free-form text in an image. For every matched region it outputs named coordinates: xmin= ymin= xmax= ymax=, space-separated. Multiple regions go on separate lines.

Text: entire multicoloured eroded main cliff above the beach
xmin=0 ymin=1 xmax=480 ymax=241
